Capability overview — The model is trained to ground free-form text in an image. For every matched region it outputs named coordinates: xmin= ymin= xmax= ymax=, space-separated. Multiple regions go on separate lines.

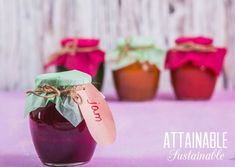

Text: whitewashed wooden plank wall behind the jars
xmin=0 ymin=0 xmax=235 ymax=91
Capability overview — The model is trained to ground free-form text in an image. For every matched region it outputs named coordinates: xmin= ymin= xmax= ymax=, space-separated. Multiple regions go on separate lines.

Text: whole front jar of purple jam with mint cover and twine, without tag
xmin=26 ymin=71 xmax=96 ymax=166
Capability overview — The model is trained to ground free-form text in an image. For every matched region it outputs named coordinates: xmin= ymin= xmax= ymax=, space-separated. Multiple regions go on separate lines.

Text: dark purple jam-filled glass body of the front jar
xmin=30 ymin=103 xmax=96 ymax=166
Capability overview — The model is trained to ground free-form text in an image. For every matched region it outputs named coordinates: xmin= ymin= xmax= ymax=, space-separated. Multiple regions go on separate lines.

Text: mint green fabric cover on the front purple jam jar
xmin=25 ymin=70 xmax=91 ymax=127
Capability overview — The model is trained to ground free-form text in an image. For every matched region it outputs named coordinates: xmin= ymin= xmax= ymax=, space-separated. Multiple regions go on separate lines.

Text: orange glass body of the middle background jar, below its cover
xmin=113 ymin=62 xmax=160 ymax=101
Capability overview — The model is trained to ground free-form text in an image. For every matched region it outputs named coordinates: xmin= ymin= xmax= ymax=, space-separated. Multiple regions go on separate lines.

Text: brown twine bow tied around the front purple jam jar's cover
xmin=26 ymin=84 xmax=84 ymax=104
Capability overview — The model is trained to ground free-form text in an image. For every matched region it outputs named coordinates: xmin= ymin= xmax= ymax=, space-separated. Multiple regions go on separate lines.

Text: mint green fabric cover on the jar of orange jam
xmin=108 ymin=36 xmax=165 ymax=70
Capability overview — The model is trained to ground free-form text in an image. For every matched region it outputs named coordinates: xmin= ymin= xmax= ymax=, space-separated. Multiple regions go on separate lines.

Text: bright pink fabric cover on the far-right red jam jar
xmin=165 ymin=37 xmax=227 ymax=75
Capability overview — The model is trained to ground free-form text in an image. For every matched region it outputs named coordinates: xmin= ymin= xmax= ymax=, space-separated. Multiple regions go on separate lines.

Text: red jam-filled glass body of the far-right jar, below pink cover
xmin=171 ymin=63 xmax=217 ymax=100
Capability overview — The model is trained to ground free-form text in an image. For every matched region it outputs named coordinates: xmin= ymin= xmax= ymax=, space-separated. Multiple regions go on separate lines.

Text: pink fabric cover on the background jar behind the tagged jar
xmin=44 ymin=38 xmax=105 ymax=77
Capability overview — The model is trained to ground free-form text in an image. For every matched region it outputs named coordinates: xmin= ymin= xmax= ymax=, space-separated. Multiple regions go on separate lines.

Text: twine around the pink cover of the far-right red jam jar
xmin=172 ymin=42 xmax=216 ymax=52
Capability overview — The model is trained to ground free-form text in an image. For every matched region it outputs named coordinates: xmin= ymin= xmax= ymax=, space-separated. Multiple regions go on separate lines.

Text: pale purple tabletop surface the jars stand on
xmin=0 ymin=92 xmax=235 ymax=167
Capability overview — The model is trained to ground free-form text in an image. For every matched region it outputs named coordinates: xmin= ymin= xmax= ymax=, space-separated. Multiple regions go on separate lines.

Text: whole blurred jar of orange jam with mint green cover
xmin=109 ymin=37 xmax=164 ymax=101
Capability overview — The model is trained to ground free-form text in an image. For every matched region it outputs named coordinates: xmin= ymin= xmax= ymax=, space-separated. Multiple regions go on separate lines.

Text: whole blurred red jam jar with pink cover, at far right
xmin=165 ymin=37 xmax=226 ymax=100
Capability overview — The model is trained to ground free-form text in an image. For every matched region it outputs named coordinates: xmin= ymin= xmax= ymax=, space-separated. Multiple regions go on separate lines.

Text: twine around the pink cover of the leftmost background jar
xmin=49 ymin=40 xmax=99 ymax=62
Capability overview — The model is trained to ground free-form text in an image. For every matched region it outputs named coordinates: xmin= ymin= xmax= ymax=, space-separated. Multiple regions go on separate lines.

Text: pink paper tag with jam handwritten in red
xmin=78 ymin=84 xmax=116 ymax=145
